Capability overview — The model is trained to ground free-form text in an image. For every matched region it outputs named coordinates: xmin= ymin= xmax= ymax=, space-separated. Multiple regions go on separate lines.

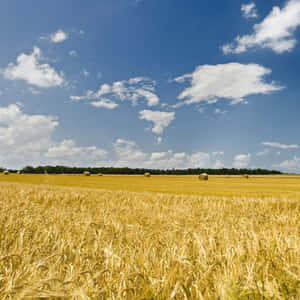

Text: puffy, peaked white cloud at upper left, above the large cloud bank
xmin=2 ymin=47 xmax=65 ymax=88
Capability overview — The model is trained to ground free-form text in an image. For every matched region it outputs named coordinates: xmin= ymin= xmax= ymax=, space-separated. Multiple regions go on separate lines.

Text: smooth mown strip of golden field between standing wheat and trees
xmin=0 ymin=174 xmax=300 ymax=197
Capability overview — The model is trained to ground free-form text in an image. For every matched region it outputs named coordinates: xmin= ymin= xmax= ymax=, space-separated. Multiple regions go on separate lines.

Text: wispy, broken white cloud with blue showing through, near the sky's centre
xmin=70 ymin=77 xmax=159 ymax=106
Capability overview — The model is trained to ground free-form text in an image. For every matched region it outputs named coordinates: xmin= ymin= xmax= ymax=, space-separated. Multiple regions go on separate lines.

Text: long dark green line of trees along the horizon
xmin=0 ymin=166 xmax=282 ymax=175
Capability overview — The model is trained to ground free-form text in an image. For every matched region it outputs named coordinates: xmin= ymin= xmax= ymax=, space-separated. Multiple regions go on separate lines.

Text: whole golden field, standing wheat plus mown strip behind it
xmin=0 ymin=175 xmax=300 ymax=299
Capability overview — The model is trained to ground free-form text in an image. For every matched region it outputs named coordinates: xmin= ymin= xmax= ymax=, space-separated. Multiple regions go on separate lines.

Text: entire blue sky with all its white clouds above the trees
xmin=0 ymin=0 xmax=300 ymax=172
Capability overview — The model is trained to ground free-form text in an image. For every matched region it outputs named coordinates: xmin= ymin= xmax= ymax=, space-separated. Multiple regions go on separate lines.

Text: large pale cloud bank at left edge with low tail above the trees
xmin=0 ymin=104 xmax=107 ymax=168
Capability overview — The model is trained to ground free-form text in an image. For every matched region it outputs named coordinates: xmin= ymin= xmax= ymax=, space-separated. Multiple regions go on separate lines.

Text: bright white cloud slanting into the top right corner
xmin=223 ymin=0 xmax=300 ymax=54
